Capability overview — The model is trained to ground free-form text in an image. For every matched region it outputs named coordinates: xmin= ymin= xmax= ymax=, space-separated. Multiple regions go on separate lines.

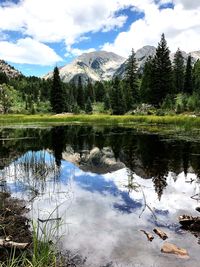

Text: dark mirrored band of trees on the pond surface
xmin=0 ymin=126 xmax=200 ymax=196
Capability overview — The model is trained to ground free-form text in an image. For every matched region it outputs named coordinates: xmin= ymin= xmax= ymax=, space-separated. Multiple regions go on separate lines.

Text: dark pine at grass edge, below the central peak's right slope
xmin=110 ymin=77 xmax=126 ymax=115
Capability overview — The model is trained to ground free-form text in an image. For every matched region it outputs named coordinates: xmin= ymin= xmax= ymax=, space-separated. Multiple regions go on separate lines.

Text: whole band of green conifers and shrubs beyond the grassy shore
xmin=0 ymin=34 xmax=200 ymax=115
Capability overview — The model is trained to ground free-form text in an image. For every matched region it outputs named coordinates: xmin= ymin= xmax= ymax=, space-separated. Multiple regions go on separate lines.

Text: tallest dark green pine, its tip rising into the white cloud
xmin=150 ymin=34 xmax=173 ymax=106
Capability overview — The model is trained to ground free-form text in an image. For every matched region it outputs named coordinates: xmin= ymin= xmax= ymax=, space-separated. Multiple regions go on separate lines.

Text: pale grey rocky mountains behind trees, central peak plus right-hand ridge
xmin=44 ymin=45 xmax=200 ymax=83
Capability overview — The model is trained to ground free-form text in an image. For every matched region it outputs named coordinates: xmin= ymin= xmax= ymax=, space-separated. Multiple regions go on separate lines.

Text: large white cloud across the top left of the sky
xmin=0 ymin=0 xmax=132 ymax=45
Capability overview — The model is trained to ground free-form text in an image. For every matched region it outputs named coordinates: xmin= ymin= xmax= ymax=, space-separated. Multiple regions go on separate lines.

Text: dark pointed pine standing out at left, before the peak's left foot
xmin=50 ymin=67 xmax=65 ymax=113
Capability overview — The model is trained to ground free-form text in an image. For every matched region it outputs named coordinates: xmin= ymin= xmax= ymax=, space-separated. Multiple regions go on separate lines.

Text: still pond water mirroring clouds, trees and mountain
xmin=0 ymin=125 xmax=200 ymax=267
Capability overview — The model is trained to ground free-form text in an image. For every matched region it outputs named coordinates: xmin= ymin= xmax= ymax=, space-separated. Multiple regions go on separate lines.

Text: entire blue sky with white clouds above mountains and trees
xmin=0 ymin=0 xmax=200 ymax=76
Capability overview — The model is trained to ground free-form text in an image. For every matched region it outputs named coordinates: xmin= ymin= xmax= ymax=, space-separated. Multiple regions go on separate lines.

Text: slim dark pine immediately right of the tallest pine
xmin=173 ymin=49 xmax=185 ymax=93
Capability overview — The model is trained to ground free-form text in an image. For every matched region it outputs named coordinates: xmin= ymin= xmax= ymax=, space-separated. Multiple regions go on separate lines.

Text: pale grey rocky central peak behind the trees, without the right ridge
xmin=44 ymin=51 xmax=126 ymax=82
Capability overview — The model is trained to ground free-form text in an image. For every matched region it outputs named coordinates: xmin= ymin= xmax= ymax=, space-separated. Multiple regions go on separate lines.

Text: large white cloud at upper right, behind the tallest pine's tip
xmin=102 ymin=0 xmax=200 ymax=56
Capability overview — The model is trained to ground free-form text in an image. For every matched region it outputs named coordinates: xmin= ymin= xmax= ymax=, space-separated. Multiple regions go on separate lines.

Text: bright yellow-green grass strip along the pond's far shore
xmin=0 ymin=114 xmax=200 ymax=128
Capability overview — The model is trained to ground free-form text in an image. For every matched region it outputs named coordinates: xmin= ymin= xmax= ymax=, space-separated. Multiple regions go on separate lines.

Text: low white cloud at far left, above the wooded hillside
xmin=0 ymin=38 xmax=62 ymax=65
